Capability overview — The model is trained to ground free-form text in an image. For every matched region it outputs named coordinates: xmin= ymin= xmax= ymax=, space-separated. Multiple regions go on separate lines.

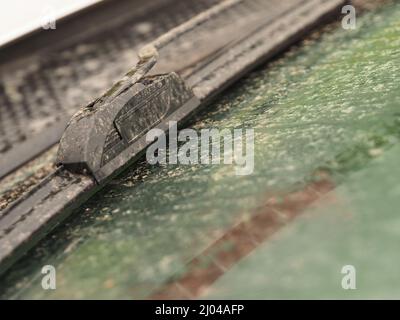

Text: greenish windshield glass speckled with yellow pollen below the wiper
xmin=0 ymin=4 xmax=400 ymax=299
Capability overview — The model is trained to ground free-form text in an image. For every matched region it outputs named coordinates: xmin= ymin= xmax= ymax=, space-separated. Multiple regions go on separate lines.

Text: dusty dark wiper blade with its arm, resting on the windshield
xmin=0 ymin=0 xmax=344 ymax=272
